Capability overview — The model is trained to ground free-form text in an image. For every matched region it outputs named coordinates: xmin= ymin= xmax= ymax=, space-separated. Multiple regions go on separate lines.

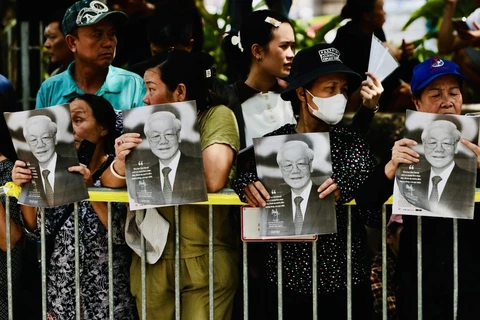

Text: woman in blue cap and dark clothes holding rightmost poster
xmin=356 ymin=57 xmax=480 ymax=320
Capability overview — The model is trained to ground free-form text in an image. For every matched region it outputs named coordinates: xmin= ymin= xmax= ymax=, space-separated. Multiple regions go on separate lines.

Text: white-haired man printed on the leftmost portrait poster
xmin=19 ymin=115 xmax=88 ymax=207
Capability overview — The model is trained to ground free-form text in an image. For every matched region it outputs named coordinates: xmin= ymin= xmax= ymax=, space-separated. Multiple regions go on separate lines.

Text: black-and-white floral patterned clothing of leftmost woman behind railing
xmin=29 ymin=160 xmax=138 ymax=320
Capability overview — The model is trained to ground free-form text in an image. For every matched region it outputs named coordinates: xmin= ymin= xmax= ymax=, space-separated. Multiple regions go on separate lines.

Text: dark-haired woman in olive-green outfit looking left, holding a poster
xmin=103 ymin=50 xmax=239 ymax=320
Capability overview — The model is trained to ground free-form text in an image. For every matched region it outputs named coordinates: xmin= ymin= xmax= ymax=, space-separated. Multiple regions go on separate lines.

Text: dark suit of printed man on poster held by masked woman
xmin=262 ymin=184 xmax=337 ymax=236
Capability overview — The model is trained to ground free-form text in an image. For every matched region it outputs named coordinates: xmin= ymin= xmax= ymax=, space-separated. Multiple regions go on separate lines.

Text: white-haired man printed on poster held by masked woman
xmin=265 ymin=140 xmax=336 ymax=236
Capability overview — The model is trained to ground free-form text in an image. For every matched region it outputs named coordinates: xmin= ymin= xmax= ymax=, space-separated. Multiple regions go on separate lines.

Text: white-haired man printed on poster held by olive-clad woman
xmin=128 ymin=111 xmax=208 ymax=205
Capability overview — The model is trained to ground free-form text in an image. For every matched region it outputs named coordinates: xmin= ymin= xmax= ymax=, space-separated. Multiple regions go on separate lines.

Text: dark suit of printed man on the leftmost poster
xmin=19 ymin=154 xmax=88 ymax=207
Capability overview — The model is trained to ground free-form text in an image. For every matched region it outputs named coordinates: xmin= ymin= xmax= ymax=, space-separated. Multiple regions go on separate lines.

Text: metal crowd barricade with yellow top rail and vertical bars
xmin=0 ymin=188 xmax=480 ymax=320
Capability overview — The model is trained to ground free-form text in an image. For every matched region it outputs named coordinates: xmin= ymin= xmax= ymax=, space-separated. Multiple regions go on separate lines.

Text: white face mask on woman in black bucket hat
xmin=305 ymin=89 xmax=347 ymax=125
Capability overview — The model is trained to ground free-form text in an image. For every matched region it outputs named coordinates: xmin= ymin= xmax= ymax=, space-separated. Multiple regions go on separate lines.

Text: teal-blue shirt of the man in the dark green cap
xmin=35 ymin=62 xmax=146 ymax=110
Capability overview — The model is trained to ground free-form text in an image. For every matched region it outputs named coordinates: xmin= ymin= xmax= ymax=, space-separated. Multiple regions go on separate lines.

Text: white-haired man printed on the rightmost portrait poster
xmin=407 ymin=120 xmax=475 ymax=218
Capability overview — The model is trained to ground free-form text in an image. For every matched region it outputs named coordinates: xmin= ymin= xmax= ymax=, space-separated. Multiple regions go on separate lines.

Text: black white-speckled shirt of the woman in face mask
xmin=233 ymin=124 xmax=381 ymax=293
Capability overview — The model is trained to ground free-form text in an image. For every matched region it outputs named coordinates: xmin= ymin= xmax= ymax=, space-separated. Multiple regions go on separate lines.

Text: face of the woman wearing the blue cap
xmin=413 ymin=75 xmax=463 ymax=114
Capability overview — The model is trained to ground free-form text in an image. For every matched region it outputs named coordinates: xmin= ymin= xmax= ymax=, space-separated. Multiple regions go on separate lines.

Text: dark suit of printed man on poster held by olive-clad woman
xmin=128 ymin=152 xmax=208 ymax=206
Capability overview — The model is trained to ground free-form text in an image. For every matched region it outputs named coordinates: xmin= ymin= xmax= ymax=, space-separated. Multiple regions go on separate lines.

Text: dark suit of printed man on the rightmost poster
xmin=402 ymin=164 xmax=475 ymax=218
